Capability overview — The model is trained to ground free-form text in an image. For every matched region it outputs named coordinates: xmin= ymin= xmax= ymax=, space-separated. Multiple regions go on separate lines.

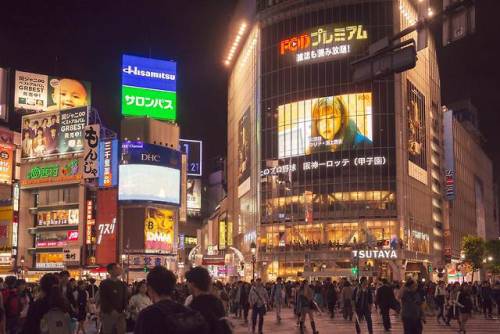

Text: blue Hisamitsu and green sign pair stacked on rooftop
xmin=122 ymin=55 xmax=177 ymax=121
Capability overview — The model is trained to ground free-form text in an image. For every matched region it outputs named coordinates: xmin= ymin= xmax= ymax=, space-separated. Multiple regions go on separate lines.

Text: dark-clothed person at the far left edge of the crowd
xmin=2 ymin=276 xmax=23 ymax=334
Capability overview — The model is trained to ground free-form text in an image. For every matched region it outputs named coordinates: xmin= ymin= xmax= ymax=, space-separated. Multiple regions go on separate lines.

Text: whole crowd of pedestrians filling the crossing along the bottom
xmin=0 ymin=263 xmax=500 ymax=334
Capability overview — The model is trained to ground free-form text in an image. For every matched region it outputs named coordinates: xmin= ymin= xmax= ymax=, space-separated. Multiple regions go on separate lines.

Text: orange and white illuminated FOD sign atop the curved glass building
xmin=279 ymin=24 xmax=368 ymax=63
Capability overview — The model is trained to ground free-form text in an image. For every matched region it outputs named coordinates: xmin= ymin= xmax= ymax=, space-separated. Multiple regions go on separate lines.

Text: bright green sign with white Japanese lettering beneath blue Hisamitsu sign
xmin=122 ymin=86 xmax=177 ymax=121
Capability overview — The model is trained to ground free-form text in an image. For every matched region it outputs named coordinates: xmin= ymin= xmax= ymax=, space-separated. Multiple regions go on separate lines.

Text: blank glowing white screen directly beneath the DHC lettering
xmin=118 ymin=164 xmax=181 ymax=205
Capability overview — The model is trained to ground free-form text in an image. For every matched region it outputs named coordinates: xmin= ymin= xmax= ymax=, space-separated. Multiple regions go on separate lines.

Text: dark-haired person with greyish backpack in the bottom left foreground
xmin=21 ymin=274 xmax=72 ymax=334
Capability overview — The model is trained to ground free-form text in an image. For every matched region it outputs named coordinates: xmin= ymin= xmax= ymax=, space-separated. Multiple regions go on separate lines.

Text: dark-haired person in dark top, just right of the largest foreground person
xmin=186 ymin=267 xmax=232 ymax=334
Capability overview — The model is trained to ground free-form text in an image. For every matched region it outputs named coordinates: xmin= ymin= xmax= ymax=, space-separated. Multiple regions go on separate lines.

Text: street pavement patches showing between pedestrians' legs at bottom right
xmin=232 ymin=309 xmax=500 ymax=334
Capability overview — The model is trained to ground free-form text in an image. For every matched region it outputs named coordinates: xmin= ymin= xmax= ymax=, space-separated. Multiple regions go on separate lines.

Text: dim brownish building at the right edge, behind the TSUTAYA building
xmin=443 ymin=100 xmax=499 ymax=280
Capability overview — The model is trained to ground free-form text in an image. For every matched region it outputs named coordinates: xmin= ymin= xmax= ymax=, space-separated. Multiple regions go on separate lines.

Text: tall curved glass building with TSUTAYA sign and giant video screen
xmin=226 ymin=0 xmax=444 ymax=280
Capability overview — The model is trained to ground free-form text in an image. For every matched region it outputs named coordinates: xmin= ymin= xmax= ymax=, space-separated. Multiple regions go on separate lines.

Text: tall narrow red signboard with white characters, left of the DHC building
xmin=95 ymin=188 xmax=118 ymax=265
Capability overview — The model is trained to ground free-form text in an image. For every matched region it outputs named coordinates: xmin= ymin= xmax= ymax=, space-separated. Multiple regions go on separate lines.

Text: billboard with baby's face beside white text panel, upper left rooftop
xmin=14 ymin=71 xmax=91 ymax=114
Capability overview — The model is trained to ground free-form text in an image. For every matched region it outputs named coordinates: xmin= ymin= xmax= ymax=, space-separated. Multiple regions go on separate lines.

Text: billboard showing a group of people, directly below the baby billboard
xmin=21 ymin=107 xmax=87 ymax=159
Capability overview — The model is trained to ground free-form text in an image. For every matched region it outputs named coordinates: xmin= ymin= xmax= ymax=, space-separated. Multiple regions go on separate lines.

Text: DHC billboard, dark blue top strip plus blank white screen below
xmin=118 ymin=142 xmax=181 ymax=205
